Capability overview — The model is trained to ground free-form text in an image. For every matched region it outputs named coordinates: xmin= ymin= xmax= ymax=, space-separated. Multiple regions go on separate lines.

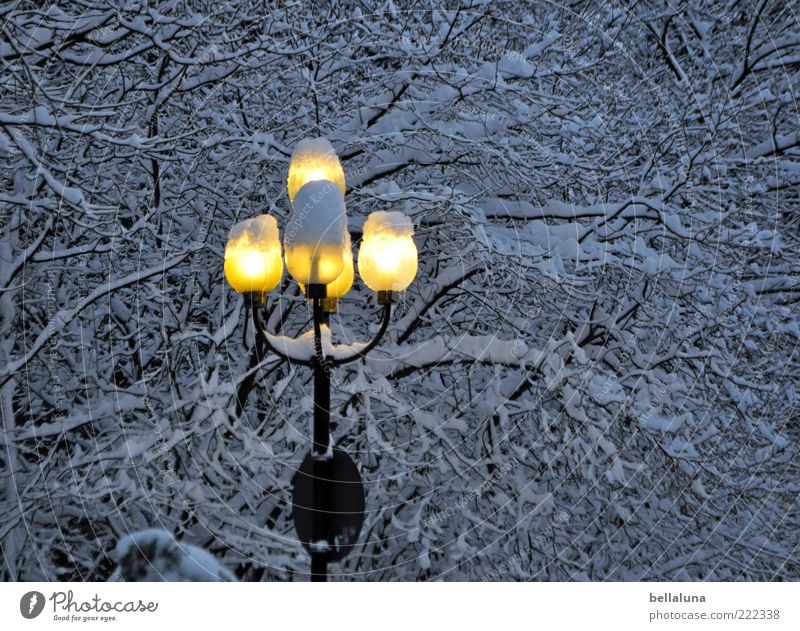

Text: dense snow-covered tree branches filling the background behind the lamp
xmin=0 ymin=0 xmax=800 ymax=581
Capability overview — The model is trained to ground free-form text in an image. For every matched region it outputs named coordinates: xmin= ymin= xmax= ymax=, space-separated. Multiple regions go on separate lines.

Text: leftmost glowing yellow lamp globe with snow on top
xmin=225 ymin=215 xmax=283 ymax=294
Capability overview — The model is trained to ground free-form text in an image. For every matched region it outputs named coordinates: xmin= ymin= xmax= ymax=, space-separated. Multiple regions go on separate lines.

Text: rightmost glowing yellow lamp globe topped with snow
xmin=358 ymin=211 xmax=417 ymax=292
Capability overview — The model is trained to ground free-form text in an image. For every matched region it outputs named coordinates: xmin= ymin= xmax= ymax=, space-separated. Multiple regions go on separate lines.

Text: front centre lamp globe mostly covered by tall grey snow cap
xmin=283 ymin=180 xmax=349 ymax=286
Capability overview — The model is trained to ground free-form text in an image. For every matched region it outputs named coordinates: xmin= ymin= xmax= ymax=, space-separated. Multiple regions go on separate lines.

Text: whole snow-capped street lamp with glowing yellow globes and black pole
xmin=220 ymin=138 xmax=417 ymax=581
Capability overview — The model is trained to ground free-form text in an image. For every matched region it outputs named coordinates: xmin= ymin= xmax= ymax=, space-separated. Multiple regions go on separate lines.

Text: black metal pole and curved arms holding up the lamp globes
xmin=246 ymin=284 xmax=395 ymax=582
